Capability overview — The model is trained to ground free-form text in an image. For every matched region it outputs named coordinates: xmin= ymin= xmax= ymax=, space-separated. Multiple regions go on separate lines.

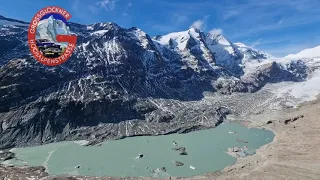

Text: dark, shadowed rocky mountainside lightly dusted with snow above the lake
xmin=0 ymin=18 xmax=306 ymax=148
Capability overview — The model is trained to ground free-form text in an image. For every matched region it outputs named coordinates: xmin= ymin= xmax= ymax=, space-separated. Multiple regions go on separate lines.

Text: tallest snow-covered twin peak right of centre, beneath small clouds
xmin=153 ymin=28 xmax=278 ymax=75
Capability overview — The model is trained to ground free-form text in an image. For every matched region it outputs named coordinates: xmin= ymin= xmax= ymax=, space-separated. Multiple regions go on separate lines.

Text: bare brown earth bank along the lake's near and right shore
xmin=0 ymin=100 xmax=320 ymax=180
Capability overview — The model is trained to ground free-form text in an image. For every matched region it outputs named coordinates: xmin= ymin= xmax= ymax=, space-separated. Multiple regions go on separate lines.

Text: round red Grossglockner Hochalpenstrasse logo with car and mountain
xmin=28 ymin=6 xmax=77 ymax=66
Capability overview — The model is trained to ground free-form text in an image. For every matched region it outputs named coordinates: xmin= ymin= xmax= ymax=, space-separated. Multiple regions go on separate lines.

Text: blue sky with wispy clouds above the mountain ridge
xmin=0 ymin=0 xmax=320 ymax=57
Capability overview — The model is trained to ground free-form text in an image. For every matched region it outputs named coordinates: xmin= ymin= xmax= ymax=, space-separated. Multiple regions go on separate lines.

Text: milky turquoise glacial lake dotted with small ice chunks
xmin=5 ymin=123 xmax=274 ymax=177
